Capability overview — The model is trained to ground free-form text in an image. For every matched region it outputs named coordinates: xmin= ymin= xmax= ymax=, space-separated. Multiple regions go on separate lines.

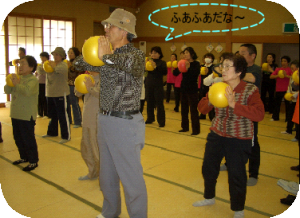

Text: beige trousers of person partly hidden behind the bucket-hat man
xmin=81 ymin=127 xmax=100 ymax=179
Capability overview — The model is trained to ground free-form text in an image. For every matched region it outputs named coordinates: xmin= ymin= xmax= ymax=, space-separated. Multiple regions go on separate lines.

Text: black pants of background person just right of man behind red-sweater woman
xmin=261 ymin=81 xmax=276 ymax=113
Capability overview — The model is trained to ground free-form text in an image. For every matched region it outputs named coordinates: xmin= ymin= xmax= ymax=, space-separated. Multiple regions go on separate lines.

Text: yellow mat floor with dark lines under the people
xmin=0 ymin=101 xmax=299 ymax=218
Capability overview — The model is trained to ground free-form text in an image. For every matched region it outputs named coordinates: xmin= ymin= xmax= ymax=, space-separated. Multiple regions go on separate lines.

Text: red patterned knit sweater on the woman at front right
xmin=198 ymin=81 xmax=265 ymax=140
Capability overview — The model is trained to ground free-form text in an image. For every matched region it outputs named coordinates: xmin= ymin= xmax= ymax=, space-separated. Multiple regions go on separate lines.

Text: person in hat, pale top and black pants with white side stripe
xmin=43 ymin=47 xmax=71 ymax=144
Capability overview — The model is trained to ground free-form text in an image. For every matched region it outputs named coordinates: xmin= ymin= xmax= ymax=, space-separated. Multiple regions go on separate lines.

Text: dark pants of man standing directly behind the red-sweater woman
xmin=249 ymin=122 xmax=260 ymax=179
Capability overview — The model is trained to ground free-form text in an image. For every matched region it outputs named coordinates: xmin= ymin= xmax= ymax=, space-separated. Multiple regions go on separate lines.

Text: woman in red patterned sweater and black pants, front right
xmin=193 ymin=55 xmax=264 ymax=218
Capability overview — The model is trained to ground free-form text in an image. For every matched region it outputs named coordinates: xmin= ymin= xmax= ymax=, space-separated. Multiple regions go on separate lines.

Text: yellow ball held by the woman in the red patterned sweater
xmin=208 ymin=82 xmax=229 ymax=108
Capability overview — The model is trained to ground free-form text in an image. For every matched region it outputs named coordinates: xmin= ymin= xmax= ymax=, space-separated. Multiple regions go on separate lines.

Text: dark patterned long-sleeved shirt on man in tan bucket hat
xmin=75 ymin=43 xmax=145 ymax=111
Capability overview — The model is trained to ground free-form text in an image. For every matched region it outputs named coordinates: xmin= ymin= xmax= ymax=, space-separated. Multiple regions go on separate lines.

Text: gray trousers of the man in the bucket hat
xmin=98 ymin=113 xmax=147 ymax=218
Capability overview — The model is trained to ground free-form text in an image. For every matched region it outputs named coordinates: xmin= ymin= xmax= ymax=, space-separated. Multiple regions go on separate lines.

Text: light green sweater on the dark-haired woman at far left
xmin=4 ymin=74 xmax=39 ymax=121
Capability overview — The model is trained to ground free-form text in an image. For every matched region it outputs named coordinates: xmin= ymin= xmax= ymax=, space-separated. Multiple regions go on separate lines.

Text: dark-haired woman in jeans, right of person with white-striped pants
xmin=68 ymin=47 xmax=84 ymax=128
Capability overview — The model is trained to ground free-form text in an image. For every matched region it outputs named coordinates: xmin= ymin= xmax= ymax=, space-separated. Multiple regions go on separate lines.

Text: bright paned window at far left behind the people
xmin=0 ymin=16 xmax=74 ymax=103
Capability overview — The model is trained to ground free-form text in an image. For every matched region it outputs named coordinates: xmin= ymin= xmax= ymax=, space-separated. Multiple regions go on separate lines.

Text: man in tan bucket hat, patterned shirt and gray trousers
xmin=75 ymin=9 xmax=147 ymax=218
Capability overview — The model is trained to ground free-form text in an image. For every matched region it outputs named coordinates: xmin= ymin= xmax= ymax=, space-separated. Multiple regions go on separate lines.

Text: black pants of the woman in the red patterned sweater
xmin=202 ymin=132 xmax=251 ymax=211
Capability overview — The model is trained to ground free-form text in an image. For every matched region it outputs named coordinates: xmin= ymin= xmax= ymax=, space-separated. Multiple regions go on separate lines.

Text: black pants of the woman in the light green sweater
xmin=11 ymin=117 xmax=39 ymax=163
